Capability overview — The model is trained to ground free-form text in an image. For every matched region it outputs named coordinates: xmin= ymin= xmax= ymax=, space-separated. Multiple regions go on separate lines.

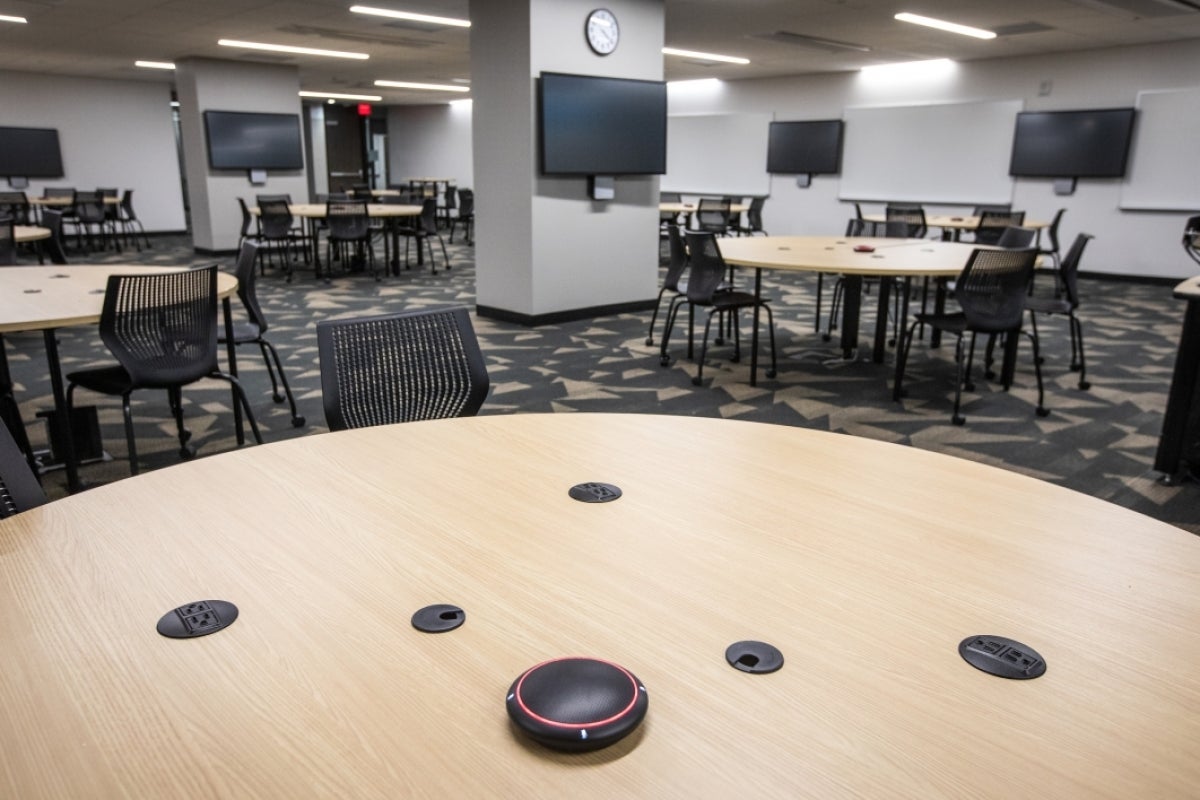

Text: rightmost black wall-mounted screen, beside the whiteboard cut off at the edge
xmin=1008 ymin=108 xmax=1136 ymax=178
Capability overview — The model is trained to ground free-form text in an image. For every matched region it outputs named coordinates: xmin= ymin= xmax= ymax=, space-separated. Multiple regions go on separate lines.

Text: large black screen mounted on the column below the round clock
xmin=538 ymin=72 xmax=667 ymax=175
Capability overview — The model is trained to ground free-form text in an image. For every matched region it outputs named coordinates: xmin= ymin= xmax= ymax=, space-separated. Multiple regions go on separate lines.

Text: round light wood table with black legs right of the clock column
xmin=718 ymin=236 xmax=976 ymax=385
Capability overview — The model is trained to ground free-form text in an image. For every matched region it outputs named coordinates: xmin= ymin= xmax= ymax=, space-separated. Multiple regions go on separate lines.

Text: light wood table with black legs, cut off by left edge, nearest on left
xmin=0 ymin=264 xmax=244 ymax=491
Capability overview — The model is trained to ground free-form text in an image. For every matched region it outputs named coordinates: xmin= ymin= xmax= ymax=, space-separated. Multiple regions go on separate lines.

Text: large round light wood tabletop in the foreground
xmin=0 ymin=414 xmax=1200 ymax=800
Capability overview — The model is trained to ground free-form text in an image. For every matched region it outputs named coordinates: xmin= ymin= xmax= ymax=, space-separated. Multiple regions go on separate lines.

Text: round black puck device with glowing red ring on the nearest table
xmin=506 ymin=657 xmax=649 ymax=752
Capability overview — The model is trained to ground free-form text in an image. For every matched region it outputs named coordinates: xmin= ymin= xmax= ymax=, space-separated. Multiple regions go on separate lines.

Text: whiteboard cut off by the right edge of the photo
xmin=1118 ymin=88 xmax=1200 ymax=211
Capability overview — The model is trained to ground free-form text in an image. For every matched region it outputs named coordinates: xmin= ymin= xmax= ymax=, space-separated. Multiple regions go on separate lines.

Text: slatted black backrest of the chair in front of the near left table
xmin=100 ymin=265 xmax=217 ymax=389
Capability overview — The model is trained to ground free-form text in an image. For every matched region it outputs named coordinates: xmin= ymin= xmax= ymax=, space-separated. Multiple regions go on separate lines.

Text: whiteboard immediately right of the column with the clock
xmin=659 ymin=114 xmax=772 ymax=197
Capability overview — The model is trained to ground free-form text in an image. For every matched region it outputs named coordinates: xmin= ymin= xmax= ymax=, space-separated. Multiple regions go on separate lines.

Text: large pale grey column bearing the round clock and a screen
xmin=470 ymin=0 xmax=664 ymax=324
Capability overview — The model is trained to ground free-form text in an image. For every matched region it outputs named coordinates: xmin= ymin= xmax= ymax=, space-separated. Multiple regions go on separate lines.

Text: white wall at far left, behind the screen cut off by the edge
xmin=0 ymin=72 xmax=186 ymax=231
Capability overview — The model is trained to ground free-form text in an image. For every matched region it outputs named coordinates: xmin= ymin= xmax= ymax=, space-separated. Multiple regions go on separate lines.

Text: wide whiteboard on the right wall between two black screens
xmin=839 ymin=100 xmax=1025 ymax=205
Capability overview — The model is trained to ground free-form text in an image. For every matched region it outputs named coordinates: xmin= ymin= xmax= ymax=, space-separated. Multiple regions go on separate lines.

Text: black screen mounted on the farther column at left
xmin=204 ymin=112 xmax=304 ymax=169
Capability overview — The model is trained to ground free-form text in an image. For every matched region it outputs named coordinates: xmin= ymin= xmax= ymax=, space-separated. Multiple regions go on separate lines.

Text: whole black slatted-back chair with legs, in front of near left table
xmin=67 ymin=266 xmax=263 ymax=475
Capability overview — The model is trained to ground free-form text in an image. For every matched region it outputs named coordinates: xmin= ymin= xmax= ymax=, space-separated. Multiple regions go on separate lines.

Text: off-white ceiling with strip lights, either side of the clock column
xmin=0 ymin=0 xmax=1200 ymax=103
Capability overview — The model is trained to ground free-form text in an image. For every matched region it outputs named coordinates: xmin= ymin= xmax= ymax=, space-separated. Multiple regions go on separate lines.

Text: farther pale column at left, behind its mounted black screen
xmin=175 ymin=59 xmax=308 ymax=252
